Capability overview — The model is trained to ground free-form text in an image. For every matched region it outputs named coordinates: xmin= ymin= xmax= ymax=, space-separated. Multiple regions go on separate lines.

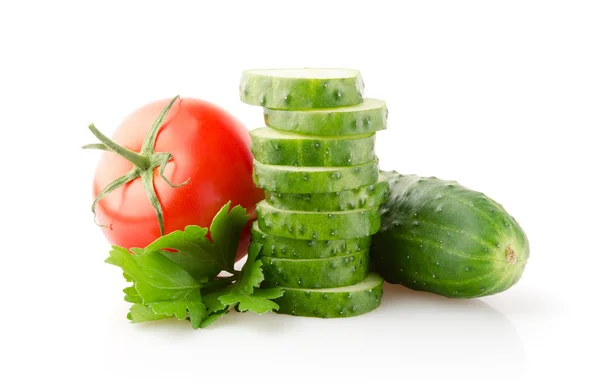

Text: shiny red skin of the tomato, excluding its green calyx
xmin=93 ymin=98 xmax=264 ymax=260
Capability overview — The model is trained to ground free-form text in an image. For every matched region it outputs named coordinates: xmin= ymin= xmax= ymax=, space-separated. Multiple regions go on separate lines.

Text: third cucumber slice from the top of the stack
xmin=250 ymin=128 xmax=377 ymax=167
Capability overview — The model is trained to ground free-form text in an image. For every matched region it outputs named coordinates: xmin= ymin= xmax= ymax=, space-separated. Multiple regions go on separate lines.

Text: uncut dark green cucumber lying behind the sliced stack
xmin=371 ymin=173 xmax=529 ymax=298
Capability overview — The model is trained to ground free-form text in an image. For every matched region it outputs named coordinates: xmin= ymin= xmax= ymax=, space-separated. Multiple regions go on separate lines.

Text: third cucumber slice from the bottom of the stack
xmin=252 ymin=221 xmax=371 ymax=259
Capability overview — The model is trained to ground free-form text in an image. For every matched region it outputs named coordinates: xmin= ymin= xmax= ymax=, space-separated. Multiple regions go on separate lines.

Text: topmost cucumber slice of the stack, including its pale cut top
xmin=240 ymin=68 xmax=364 ymax=110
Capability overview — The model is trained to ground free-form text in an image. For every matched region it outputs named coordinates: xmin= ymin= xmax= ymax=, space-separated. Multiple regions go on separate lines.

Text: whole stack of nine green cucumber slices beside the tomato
xmin=240 ymin=69 xmax=389 ymax=318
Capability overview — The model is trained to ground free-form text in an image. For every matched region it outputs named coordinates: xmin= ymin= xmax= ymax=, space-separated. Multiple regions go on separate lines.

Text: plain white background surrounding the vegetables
xmin=0 ymin=0 xmax=600 ymax=391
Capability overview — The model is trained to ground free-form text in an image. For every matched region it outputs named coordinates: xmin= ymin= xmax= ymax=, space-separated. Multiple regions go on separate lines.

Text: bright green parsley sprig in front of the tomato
xmin=106 ymin=202 xmax=283 ymax=329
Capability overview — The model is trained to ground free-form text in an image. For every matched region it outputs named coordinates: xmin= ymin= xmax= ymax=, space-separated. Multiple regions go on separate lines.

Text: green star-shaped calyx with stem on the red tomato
xmin=82 ymin=95 xmax=190 ymax=235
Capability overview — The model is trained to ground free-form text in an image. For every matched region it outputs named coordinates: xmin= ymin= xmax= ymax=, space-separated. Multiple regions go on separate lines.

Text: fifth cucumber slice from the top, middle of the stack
xmin=265 ymin=174 xmax=390 ymax=212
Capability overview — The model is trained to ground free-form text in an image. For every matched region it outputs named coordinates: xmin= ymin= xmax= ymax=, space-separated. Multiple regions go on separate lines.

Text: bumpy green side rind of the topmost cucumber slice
xmin=240 ymin=71 xmax=364 ymax=110
